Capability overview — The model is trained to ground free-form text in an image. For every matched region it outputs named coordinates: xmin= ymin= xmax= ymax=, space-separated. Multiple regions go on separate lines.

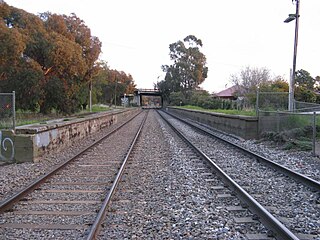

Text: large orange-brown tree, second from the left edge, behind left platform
xmin=40 ymin=13 xmax=101 ymax=112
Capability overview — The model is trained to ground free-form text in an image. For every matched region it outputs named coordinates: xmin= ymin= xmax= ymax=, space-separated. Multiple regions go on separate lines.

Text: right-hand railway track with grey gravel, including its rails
xmin=161 ymin=109 xmax=320 ymax=239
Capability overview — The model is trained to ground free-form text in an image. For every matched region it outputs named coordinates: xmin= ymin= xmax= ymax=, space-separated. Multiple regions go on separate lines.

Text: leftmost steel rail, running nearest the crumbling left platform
xmin=0 ymin=111 xmax=141 ymax=213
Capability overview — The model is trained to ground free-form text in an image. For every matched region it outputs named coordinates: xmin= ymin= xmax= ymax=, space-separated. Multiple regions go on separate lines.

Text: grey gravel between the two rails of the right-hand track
xmin=161 ymin=111 xmax=320 ymax=239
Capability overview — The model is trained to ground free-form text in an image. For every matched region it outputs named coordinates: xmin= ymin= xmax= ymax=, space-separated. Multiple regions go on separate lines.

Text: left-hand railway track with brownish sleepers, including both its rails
xmin=0 ymin=109 xmax=147 ymax=239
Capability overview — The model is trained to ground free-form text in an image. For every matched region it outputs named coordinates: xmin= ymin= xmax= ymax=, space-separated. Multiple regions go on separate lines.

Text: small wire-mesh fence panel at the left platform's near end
xmin=0 ymin=92 xmax=16 ymax=130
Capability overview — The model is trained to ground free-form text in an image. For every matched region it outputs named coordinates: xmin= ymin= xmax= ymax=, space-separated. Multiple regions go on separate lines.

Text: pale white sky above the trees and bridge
xmin=5 ymin=0 xmax=320 ymax=93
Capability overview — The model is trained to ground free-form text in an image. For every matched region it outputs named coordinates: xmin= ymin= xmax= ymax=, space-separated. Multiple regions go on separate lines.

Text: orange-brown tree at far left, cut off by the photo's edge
xmin=0 ymin=2 xmax=45 ymax=110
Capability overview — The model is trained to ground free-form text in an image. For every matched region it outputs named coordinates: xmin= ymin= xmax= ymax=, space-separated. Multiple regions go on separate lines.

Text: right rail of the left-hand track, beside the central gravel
xmin=87 ymin=112 xmax=149 ymax=240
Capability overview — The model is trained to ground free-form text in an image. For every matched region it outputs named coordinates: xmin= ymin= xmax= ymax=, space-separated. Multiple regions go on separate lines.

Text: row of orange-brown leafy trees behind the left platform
xmin=0 ymin=2 xmax=135 ymax=114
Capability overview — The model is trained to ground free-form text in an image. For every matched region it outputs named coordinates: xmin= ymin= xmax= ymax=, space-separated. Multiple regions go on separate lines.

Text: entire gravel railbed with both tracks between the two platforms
xmin=0 ymin=110 xmax=320 ymax=240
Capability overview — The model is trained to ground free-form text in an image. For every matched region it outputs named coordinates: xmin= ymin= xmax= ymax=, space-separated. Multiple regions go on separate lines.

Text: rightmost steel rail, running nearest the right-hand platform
xmin=165 ymin=112 xmax=320 ymax=191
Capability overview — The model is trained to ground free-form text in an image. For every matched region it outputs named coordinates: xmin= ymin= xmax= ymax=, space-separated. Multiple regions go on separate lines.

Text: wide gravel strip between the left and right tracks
xmin=99 ymin=109 xmax=273 ymax=239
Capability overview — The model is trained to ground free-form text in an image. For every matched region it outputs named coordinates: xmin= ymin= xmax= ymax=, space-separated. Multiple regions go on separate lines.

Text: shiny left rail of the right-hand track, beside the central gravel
xmin=159 ymin=110 xmax=299 ymax=240
